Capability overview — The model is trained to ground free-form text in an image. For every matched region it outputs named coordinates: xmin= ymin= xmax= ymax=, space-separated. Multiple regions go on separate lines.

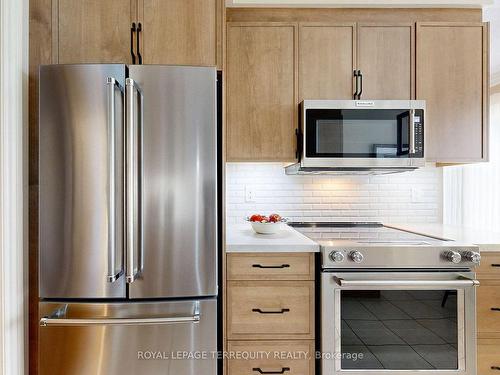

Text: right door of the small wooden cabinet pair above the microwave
xmin=357 ymin=24 xmax=415 ymax=100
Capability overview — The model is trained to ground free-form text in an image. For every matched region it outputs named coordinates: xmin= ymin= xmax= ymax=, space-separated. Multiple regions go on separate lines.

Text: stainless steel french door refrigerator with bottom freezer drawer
xmin=39 ymin=64 xmax=218 ymax=375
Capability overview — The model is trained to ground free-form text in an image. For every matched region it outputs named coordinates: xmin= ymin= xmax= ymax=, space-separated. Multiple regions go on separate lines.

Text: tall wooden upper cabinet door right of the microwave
xmin=417 ymin=23 xmax=489 ymax=163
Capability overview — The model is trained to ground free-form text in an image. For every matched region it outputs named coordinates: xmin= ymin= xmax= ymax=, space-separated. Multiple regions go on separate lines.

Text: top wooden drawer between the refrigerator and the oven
xmin=227 ymin=253 xmax=314 ymax=280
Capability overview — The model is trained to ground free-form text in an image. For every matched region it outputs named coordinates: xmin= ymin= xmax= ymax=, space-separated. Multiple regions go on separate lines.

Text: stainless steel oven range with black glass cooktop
xmin=290 ymin=222 xmax=481 ymax=375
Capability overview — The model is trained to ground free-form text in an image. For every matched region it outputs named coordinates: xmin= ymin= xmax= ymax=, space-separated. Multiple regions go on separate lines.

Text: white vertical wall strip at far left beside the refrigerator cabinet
xmin=0 ymin=0 xmax=28 ymax=375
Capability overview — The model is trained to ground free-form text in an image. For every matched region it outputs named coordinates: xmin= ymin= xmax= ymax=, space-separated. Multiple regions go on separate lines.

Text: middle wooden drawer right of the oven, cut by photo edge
xmin=477 ymin=283 xmax=500 ymax=333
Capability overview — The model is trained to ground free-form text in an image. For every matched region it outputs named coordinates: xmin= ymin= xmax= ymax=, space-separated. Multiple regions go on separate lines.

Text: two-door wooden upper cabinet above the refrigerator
xmin=52 ymin=0 xmax=224 ymax=68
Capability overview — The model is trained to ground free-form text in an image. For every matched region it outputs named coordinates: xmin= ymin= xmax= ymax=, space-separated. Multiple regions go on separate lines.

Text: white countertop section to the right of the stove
xmin=386 ymin=223 xmax=500 ymax=251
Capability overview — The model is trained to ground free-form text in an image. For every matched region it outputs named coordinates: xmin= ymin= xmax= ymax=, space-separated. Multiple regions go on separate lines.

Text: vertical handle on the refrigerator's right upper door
xmin=125 ymin=78 xmax=144 ymax=284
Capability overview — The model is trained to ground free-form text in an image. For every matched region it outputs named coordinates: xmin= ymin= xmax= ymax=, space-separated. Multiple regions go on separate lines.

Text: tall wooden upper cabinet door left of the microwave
xmin=226 ymin=23 xmax=297 ymax=161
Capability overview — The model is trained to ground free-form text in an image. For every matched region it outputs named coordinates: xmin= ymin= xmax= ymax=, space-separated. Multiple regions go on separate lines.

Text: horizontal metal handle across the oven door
xmin=333 ymin=276 xmax=479 ymax=288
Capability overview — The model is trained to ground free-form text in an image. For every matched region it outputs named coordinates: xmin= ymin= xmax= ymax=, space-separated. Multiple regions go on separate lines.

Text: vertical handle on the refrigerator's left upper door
xmin=106 ymin=77 xmax=123 ymax=283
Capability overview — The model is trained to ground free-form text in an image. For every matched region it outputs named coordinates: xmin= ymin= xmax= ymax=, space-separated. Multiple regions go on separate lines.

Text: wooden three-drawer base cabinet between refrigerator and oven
xmin=224 ymin=253 xmax=315 ymax=375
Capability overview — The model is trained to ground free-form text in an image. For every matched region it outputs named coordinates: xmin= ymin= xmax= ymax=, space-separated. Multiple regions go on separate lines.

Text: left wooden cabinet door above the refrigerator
xmin=53 ymin=0 xmax=136 ymax=64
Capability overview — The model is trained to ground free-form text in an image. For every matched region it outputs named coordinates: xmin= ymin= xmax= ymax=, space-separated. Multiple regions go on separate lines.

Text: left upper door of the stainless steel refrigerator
xmin=39 ymin=64 xmax=126 ymax=298
